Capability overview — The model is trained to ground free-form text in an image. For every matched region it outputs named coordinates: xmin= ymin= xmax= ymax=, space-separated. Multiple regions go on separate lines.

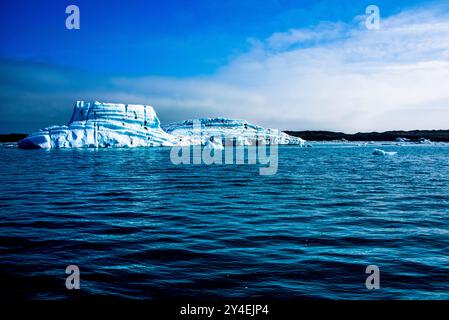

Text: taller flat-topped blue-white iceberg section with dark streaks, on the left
xmin=19 ymin=101 xmax=174 ymax=149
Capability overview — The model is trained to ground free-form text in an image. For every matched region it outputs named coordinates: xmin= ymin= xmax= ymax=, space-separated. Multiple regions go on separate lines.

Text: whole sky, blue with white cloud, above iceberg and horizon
xmin=0 ymin=0 xmax=449 ymax=133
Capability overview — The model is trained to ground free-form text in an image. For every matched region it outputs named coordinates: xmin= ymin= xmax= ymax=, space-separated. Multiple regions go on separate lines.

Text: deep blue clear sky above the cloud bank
xmin=0 ymin=0 xmax=434 ymax=76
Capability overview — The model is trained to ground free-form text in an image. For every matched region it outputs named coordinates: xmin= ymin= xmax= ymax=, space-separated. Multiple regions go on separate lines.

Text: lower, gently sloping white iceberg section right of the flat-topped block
xmin=162 ymin=118 xmax=305 ymax=146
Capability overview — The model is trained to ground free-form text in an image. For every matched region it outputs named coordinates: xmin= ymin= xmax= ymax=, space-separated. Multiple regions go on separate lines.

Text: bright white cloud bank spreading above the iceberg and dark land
xmin=1 ymin=4 xmax=449 ymax=132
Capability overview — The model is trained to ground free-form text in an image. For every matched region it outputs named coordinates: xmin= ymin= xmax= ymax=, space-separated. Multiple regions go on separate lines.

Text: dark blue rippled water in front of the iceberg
xmin=0 ymin=145 xmax=449 ymax=299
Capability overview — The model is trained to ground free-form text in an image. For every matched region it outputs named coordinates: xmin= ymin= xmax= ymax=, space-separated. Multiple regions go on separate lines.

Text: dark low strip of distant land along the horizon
xmin=0 ymin=130 xmax=449 ymax=142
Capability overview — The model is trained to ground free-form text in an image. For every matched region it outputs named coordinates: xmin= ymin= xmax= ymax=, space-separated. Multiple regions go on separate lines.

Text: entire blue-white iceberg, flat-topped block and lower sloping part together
xmin=19 ymin=101 xmax=304 ymax=149
